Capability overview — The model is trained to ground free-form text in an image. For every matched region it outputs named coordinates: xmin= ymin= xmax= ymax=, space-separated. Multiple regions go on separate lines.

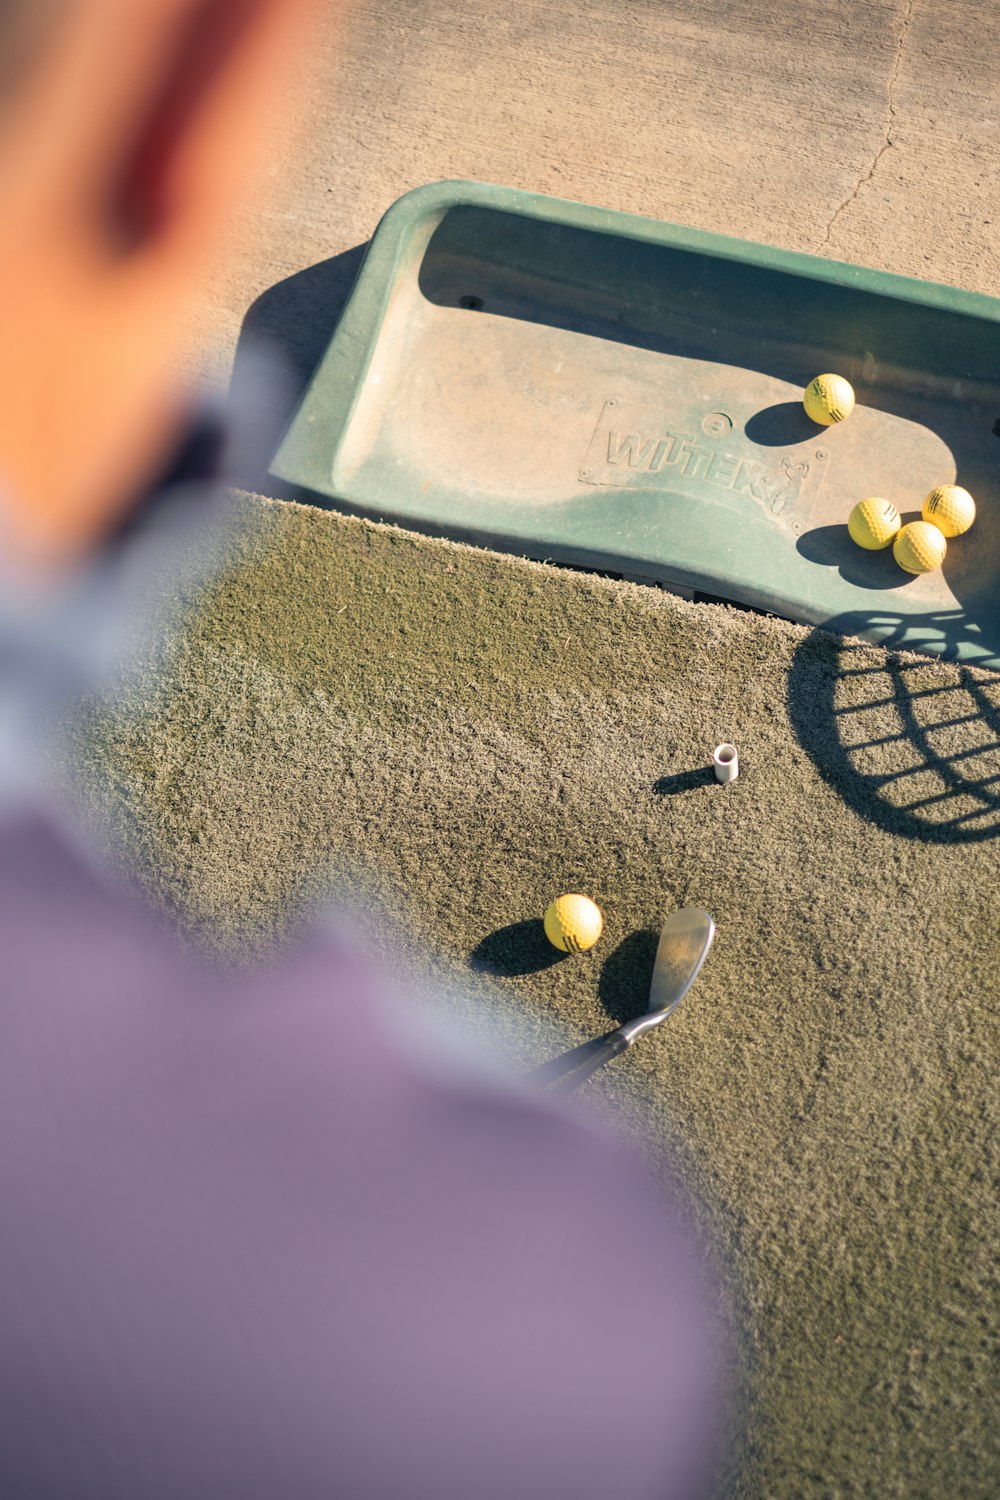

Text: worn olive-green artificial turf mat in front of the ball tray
xmin=78 ymin=495 xmax=1000 ymax=1500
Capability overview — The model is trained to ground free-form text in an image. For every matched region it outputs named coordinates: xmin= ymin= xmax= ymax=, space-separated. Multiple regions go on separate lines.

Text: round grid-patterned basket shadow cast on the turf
xmin=789 ymin=611 xmax=1000 ymax=843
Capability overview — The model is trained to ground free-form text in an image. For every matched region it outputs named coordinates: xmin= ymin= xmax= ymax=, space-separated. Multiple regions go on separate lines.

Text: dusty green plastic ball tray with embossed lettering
xmin=271 ymin=182 xmax=1000 ymax=668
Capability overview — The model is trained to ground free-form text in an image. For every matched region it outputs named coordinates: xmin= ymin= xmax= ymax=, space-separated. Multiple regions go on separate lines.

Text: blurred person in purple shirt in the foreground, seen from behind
xmin=0 ymin=0 xmax=718 ymax=1500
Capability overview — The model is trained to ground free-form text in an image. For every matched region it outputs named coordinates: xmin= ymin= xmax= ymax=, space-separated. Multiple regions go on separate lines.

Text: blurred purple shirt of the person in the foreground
xmin=0 ymin=815 xmax=714 ymax=1500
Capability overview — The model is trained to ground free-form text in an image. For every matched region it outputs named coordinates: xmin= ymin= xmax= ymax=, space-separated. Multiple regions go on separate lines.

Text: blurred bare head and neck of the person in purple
xmin=0 ymin=0 xmax=316 ymax=561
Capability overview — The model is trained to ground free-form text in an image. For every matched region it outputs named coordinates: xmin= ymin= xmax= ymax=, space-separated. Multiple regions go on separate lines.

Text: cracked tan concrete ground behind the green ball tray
xmin=195 ymin=0 xmax=1000 ymax=393
